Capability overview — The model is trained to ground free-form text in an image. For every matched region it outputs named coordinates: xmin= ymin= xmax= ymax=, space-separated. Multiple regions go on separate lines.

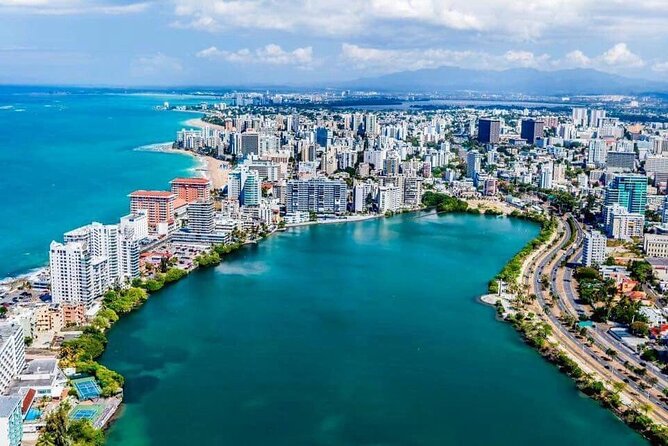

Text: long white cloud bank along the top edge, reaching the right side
xmin=171 ymin=0 xmax=668 ymax=41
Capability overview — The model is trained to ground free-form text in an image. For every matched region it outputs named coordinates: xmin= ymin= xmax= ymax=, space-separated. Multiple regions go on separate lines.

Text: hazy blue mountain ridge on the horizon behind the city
xmin=341 ymin=67 xmax=668 ymax=96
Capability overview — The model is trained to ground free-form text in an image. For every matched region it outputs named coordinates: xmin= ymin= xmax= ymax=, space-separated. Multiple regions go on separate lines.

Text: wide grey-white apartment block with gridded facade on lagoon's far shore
xmin=285 ymin=178 xmax=348 ymax=214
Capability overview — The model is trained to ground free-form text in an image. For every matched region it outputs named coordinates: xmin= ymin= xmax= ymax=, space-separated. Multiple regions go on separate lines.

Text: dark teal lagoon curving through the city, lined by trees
xmin=102 ymin=215 xmax=644 ymax=446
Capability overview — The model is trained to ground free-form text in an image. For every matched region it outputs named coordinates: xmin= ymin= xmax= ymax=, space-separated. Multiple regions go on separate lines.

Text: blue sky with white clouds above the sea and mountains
xmin=0 ymin=0 xmax=668 ymax=86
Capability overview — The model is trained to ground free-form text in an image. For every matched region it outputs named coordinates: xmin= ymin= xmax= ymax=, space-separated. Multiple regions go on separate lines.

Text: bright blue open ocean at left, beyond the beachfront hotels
xmin=0 ymin=87 xmax=197 ymax=279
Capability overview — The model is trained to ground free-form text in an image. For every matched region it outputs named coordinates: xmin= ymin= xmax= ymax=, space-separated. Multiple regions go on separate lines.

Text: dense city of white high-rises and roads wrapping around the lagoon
xmin=0 ymin=92 xmax=668 ymax=446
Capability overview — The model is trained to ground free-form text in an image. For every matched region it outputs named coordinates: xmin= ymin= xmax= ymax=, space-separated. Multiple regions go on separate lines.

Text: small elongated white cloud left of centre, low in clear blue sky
xmin=196 ymin=43 xmax=314 ymax=68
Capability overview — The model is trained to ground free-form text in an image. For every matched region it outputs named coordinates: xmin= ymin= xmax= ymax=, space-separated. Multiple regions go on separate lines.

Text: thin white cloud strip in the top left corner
xmin=0 ymin=0 xmax=151 ymax=15
